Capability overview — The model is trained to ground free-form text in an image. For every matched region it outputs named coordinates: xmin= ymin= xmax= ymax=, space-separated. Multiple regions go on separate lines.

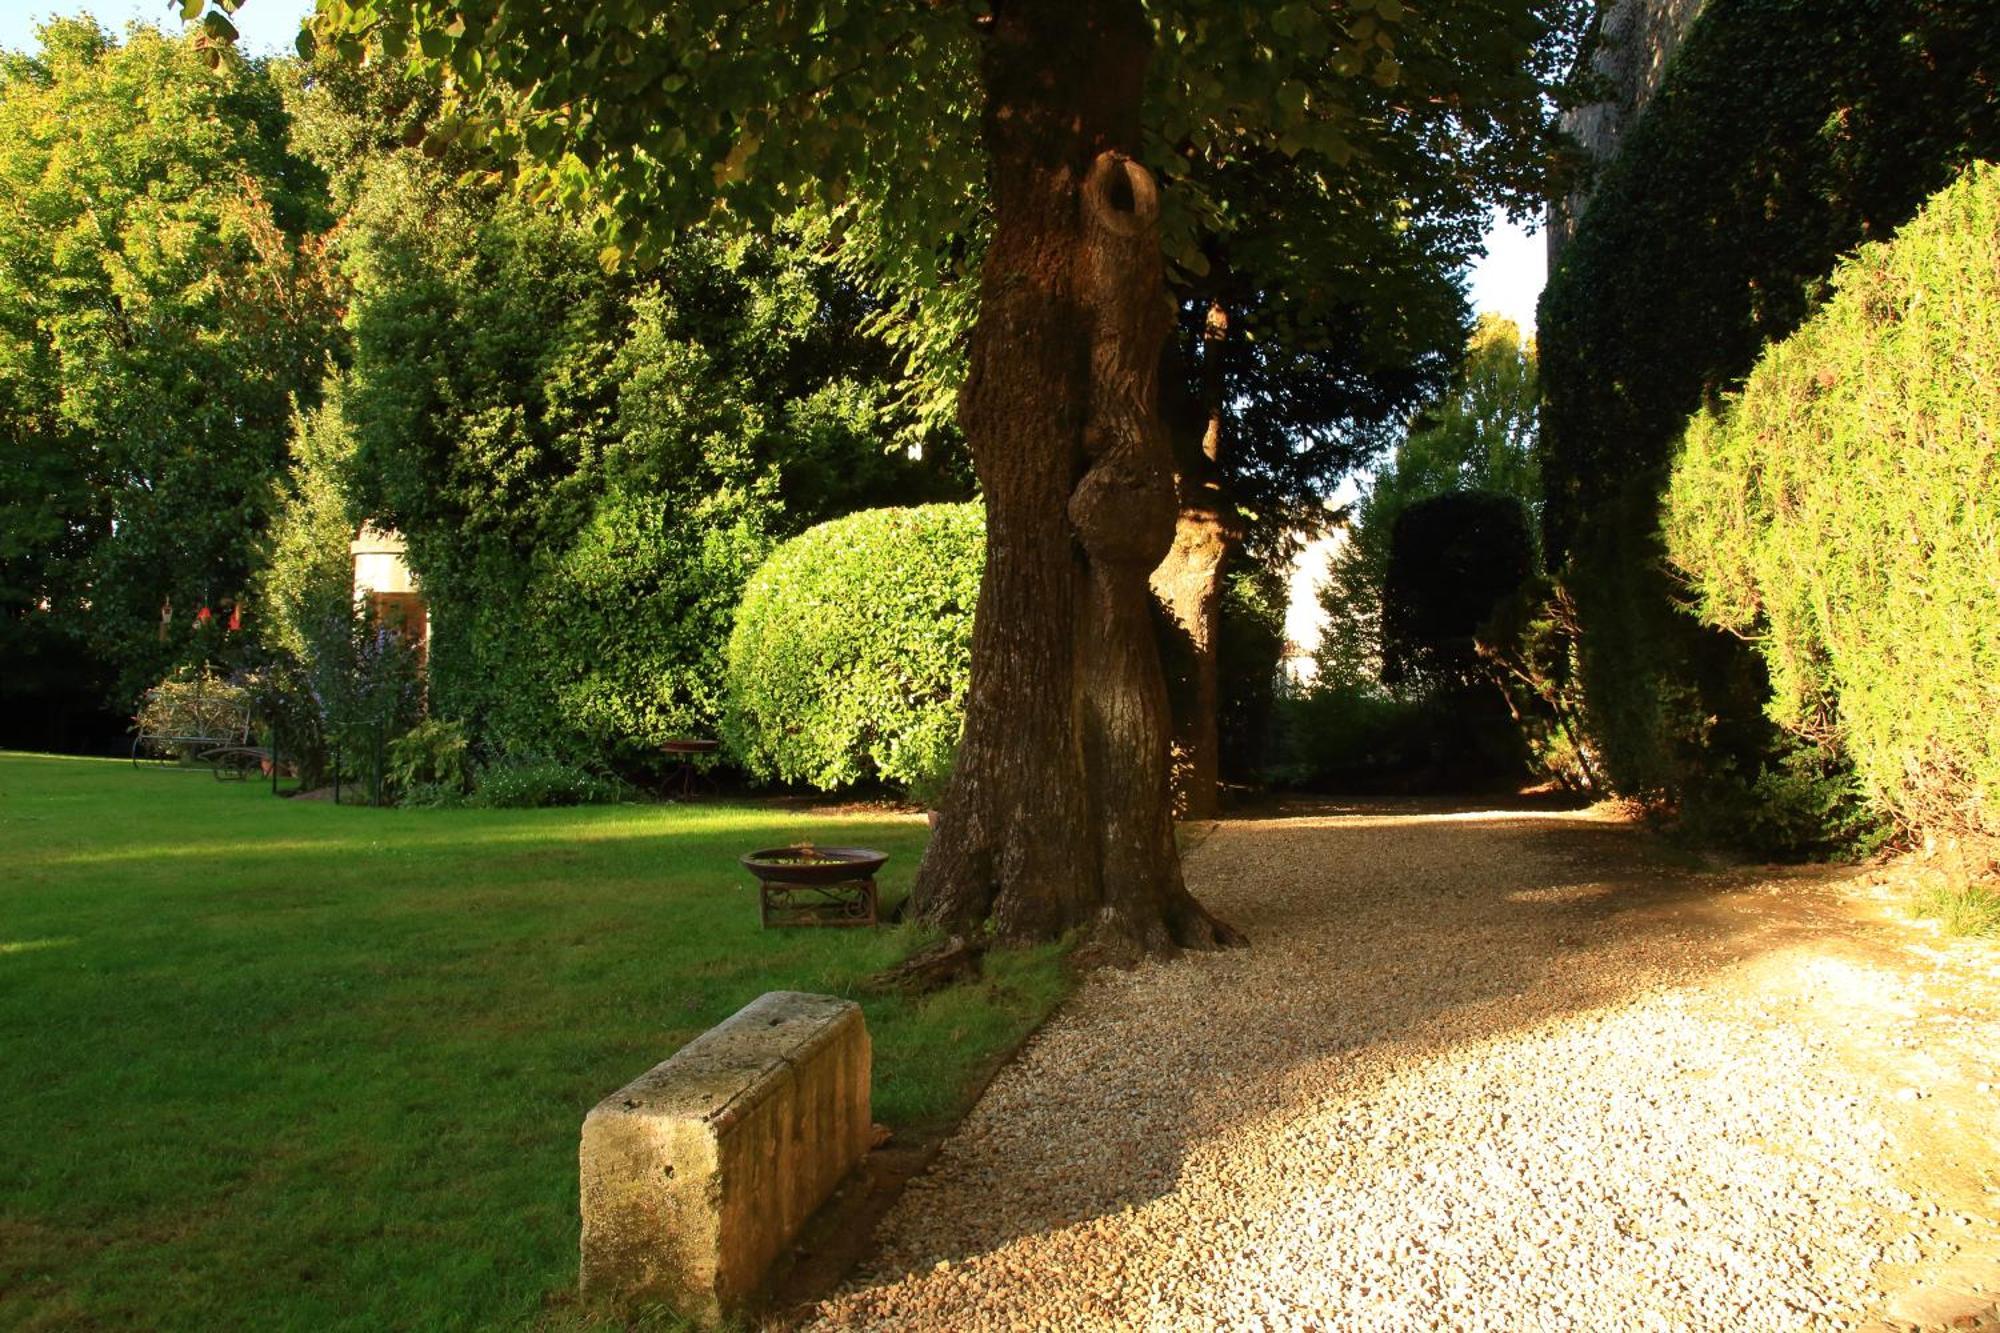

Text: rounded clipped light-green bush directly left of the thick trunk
xmin=722 ymin=504 xmax=986 ymax=791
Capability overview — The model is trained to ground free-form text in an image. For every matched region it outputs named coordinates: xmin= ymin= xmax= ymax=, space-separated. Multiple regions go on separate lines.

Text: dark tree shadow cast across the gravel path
xmin=836 ymin=803 xmax=1864 ymax=1285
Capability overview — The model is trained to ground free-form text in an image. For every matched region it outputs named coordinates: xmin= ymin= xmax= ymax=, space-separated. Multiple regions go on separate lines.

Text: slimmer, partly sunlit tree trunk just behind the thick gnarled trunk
xmin=1152 ymin=300 xmax=1242 ymax=819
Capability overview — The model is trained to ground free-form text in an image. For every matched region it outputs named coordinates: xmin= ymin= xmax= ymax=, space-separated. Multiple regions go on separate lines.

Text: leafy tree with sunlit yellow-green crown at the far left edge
xmin=0 ymin=20 xmax=336 ymax=701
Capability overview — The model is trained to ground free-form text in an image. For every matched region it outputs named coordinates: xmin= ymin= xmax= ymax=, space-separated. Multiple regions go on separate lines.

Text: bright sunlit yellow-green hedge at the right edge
xmin=1666 ymin=164 xmax=2000 ymax=835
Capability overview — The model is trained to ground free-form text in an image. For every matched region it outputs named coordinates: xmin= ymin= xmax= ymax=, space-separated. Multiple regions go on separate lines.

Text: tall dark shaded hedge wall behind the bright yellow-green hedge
xmin=1540 ymin=0 xmax=2000 ymax=849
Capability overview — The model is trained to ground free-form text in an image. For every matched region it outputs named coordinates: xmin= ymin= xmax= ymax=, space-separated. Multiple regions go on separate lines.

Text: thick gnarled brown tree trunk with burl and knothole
xmin=916 ymin=0 xmax=1238 ymax=961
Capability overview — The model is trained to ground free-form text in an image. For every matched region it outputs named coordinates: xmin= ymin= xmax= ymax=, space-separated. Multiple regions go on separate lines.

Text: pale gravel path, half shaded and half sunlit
xmin=800 ymin=813 xmax=2000 ymax=1333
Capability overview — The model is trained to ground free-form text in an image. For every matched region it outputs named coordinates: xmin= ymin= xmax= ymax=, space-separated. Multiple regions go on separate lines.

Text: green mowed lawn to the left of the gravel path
xmin=0 ymin=755 xmax=1062 ymax=1329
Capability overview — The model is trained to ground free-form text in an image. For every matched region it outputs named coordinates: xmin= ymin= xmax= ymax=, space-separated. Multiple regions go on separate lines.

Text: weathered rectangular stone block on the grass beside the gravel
xmin=578 ymin=991 xmax=870 ymax=1323
